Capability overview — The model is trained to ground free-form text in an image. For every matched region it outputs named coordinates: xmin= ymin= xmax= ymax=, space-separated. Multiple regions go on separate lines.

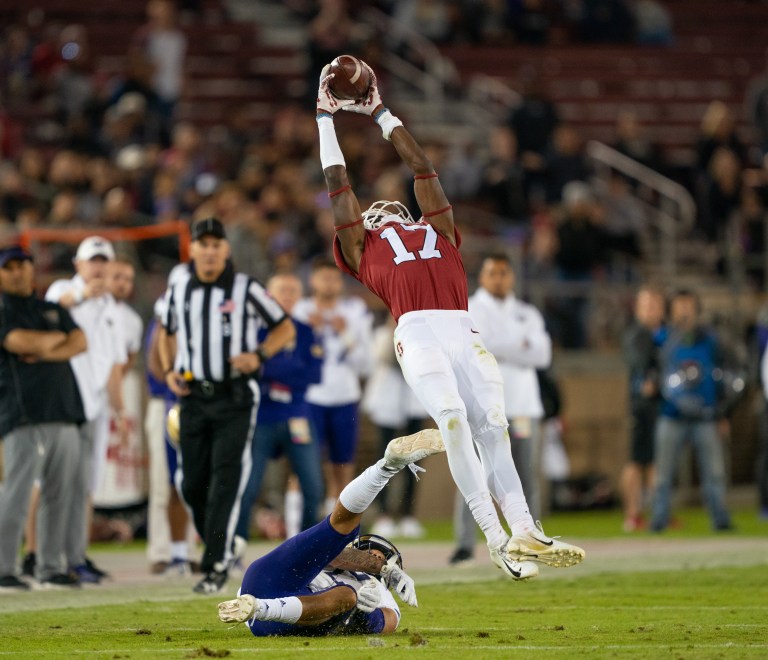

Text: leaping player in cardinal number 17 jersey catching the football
xmin=316 ymin=60 xmax=584 ymax=580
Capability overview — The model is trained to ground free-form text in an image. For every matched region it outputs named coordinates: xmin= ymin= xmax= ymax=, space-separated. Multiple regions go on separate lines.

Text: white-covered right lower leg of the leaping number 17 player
xmin=475 ymin=427 xmax=534 ymax=536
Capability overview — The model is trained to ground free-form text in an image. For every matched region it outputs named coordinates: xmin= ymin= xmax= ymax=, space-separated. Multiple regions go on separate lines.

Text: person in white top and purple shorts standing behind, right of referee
xmin=293 ymin=258 xmax=373 ymax=510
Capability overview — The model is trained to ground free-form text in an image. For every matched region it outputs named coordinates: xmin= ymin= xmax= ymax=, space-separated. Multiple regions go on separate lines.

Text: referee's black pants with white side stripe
xmin=179 ymin=386 xmax=256 ymax=573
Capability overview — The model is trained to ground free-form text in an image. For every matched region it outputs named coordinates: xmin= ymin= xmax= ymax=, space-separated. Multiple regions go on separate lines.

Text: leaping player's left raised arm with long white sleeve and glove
xmin=315 ymin=66 xmax=365 ymax=272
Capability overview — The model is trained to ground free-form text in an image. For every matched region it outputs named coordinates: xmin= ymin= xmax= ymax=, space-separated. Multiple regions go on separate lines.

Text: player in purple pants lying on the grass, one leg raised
xmin=219 ymin=429 xmax=445 ymax=637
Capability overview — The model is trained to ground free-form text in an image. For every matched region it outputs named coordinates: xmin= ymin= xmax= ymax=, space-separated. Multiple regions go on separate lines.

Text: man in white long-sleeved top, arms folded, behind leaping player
xmin=451 ymin=253 xmax=552 ymax=564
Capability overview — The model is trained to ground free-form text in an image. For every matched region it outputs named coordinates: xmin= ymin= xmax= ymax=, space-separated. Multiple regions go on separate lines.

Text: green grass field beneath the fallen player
xmin=0 ymin=512 xmax=768 ymax=659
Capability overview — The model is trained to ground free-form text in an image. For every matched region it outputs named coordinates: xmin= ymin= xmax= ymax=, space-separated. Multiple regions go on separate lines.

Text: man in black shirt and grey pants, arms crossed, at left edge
xmin=0 ymin=247 xmax=86 ymax=591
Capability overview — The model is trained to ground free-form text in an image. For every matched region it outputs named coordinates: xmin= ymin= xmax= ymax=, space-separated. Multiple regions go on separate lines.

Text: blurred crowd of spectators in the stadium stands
xmin=0 ymin=0 xmax=768 ymax=348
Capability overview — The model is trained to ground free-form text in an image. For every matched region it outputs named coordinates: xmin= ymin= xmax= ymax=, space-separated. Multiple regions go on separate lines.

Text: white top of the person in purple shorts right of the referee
xmin=292 ymin=298 xmax=373 ymax=406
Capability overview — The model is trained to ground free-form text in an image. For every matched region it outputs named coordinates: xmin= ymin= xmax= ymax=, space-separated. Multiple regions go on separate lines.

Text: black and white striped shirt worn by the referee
xmin=161 ymin=264 xmax=286 ymax=382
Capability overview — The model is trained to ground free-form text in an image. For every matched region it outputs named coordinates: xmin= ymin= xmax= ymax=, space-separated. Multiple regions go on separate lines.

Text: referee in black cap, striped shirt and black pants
xmin=160 ymin=218 xmax=296 ymax=594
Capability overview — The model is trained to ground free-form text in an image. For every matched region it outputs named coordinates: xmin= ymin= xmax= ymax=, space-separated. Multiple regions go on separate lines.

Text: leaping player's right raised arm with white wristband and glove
xmin=343 ymin=62 xmax=456 ymax=245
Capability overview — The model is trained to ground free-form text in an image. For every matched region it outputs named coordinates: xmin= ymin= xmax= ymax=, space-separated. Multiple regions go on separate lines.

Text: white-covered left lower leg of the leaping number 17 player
xmin=437 ymin=411 xmax=509 ymax=548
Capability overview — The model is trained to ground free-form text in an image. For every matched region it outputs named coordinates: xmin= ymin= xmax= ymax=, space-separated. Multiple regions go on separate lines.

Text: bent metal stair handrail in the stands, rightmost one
xmin=586 ymin=140 xmax=696 ymax=279
